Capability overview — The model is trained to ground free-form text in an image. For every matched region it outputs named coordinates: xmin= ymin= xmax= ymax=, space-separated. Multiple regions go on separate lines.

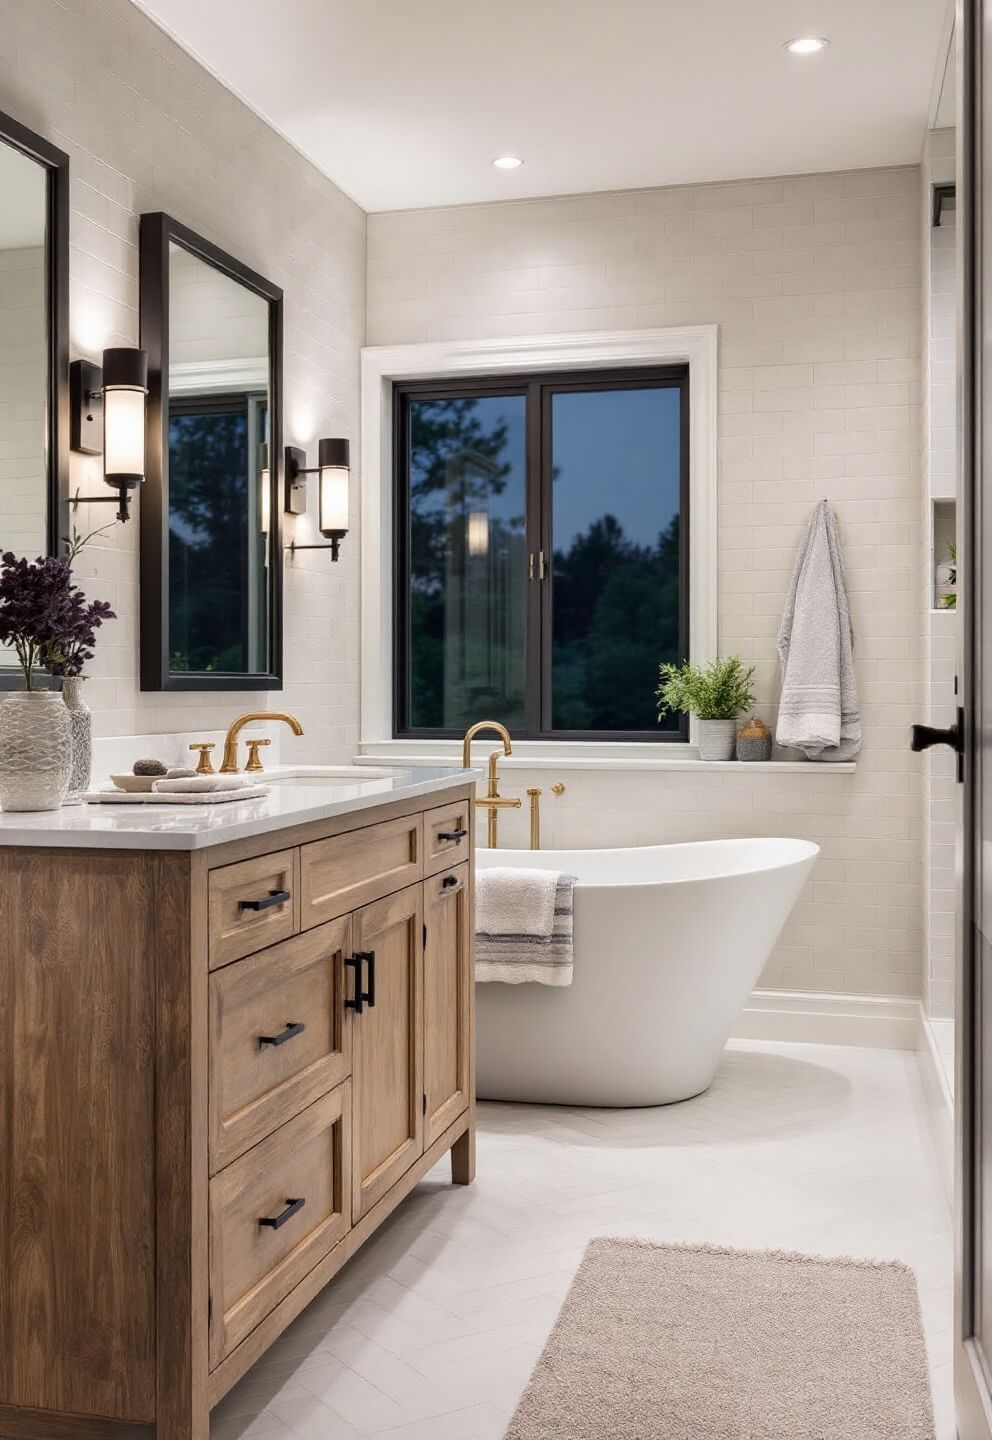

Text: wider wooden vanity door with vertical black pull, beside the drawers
xmin=351 ymin=884 xmax=423 ymax=1223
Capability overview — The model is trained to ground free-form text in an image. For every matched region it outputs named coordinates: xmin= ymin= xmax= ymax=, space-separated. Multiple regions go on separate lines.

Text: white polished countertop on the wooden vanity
xmin=0 ymin=765 xmax=479 ymax=850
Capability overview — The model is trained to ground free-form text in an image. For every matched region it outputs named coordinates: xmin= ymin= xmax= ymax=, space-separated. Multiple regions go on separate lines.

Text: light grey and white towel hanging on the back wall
xmin=775 ymin=500 xmax=861 ymax=760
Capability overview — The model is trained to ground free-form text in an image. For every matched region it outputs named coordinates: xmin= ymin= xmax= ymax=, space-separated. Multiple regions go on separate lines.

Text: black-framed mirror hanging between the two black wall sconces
xmin=140 ymin=213 xmax=282 ymax=690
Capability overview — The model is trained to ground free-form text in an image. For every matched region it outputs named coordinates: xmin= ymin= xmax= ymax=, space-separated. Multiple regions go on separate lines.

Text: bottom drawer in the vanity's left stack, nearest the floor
xmin=210 ymin=1080 xmax=351 ymax=1368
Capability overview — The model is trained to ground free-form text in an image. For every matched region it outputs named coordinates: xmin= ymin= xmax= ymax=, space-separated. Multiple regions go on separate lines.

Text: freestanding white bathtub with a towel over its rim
xmin=475 ymin=840 xmax=819 ymax=1106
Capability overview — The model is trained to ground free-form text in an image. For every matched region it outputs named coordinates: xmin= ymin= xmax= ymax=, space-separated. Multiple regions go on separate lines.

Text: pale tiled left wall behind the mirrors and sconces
xmin=0 ymin=0 xmax=366 ymax=760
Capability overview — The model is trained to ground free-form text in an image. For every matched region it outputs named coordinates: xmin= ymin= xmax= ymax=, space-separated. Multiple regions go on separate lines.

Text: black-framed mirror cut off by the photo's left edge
xmin=0 ymin=112 xmax=69 ymax=690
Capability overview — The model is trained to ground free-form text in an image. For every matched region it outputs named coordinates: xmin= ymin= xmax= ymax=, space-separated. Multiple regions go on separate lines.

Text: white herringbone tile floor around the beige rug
xmin=210 ymin=1043 xmax=955 ymax=1440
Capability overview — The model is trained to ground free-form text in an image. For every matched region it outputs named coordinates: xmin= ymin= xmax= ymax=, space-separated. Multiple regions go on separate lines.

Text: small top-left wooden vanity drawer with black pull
xmin=209 ymin=850 xmax=299 ymax=971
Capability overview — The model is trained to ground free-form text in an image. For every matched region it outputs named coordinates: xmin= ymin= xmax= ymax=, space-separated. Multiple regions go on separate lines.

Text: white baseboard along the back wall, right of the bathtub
xmin=733 ymin=991 xmax=923 ymax=1050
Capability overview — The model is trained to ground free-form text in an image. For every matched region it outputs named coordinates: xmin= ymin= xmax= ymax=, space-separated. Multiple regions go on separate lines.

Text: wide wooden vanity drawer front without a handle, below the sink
xmin=299 ymin=815 xmax=423 ymax=930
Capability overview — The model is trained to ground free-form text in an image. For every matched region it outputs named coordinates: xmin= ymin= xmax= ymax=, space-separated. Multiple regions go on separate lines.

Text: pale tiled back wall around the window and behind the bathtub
xmin=369 ymin=167 xmax=923 ymax=995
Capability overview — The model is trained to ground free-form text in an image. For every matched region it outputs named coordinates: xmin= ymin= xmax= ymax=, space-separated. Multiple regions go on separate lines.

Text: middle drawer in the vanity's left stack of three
xmin=210 ymin=917 xmax=351 ymax=1174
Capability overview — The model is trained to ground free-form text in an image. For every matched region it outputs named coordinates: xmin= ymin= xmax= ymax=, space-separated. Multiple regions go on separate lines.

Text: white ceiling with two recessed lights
xmin=129 ymin=0 xmax=947 ymax=210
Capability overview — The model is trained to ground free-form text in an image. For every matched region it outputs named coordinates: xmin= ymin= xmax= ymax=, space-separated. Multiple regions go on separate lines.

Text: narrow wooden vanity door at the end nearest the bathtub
xmin=423 ymin=865 xmax=474 ymax=1149
